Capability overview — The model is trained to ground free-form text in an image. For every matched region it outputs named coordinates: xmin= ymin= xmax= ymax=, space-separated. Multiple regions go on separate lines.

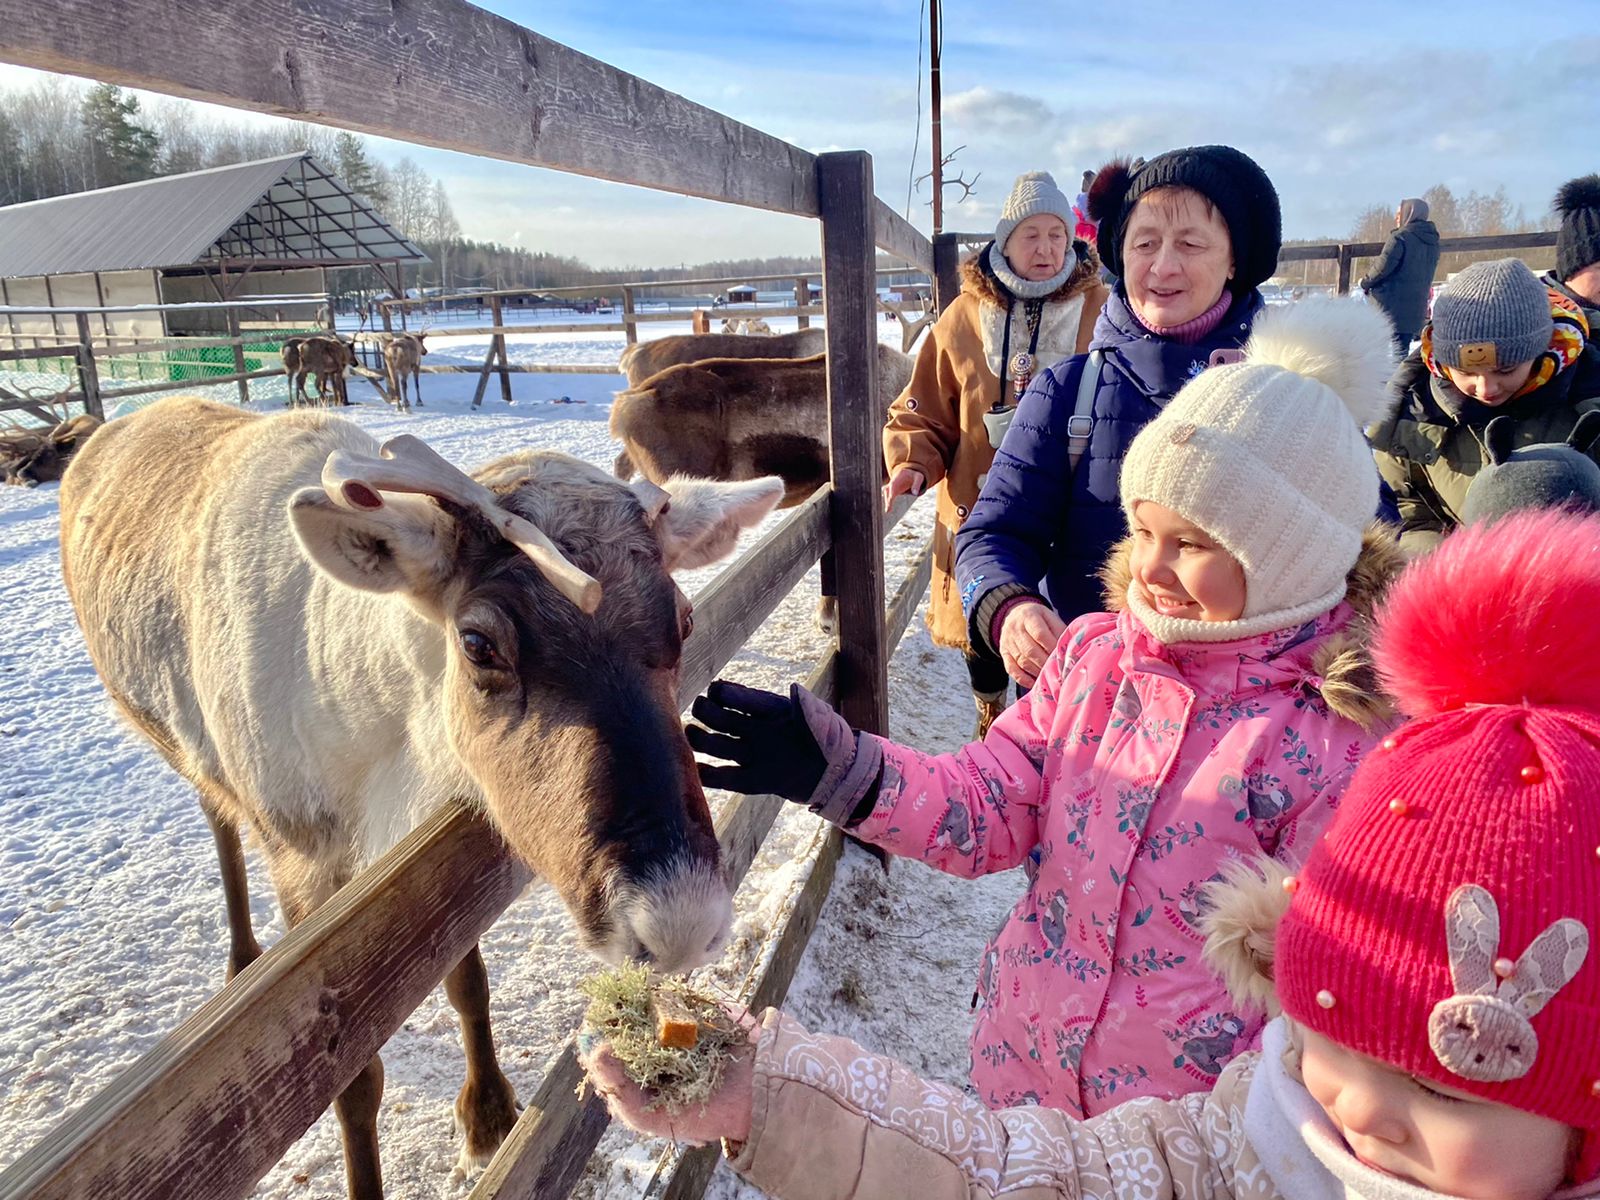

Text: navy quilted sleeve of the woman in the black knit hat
xmin=955 ymin=354 xmax=1088 ymax=650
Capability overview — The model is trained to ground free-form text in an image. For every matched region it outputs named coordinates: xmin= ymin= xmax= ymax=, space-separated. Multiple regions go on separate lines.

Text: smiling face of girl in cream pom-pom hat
xmin=1131 ymin=501 xmax=1245 ymax=621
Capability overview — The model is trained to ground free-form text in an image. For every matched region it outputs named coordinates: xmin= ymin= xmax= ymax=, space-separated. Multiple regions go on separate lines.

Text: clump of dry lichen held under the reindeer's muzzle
xmin=578 ymin=963 xmax=750 ymax=1114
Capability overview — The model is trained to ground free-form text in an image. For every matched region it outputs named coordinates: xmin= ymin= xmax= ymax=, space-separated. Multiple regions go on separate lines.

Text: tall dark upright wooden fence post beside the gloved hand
xmin=816 ymin=150 xmax=890 ymax=733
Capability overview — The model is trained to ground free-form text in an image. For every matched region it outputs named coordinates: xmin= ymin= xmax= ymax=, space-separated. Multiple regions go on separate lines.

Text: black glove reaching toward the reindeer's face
xmin=685 ymin=680 xmax=827 ymax=805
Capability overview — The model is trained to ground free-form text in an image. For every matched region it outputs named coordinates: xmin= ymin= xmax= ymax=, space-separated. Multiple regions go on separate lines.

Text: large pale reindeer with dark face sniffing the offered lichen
xmin=61 ymin=397 xmax=782 ymax=1200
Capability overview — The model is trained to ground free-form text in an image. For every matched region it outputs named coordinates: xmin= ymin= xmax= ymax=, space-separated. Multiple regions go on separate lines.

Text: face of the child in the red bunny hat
xmin=1301 ymin=1029 xmax=1579 ymax=1200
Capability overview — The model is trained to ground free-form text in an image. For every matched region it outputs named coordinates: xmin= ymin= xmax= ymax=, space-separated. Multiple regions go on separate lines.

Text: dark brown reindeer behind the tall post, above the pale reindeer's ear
xmin=611 ymin=346 xmax=912 ymax=507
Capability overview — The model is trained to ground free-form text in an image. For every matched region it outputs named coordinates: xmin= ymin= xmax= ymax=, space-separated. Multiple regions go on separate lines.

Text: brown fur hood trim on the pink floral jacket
xmin=1101 ymin=523 xmax=1405 ymax=730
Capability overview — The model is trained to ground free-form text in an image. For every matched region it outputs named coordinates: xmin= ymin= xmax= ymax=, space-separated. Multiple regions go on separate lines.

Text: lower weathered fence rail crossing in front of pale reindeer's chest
xmin=0 ymin=805 xmax=531 ymax=1200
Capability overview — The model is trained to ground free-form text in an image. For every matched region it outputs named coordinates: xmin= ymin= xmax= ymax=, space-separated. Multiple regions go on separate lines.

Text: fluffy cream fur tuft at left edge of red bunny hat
xmin=1200 ymin=858 xmax=1290 ymax=1016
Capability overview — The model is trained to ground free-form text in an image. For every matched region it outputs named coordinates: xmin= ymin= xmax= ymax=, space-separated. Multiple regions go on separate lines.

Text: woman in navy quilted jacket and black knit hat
xmin=955 ymin=146 xmax=1282 ymax=686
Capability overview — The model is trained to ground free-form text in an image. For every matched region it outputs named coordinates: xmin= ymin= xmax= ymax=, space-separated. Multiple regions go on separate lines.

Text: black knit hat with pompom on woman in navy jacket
xmin=1090 ymin=146 xmax=1283 ymax=296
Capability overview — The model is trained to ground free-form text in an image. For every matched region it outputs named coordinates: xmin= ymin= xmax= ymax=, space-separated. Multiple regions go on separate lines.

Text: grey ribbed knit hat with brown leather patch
xmin=1432 ymin=258 xmax=1555 ymax=371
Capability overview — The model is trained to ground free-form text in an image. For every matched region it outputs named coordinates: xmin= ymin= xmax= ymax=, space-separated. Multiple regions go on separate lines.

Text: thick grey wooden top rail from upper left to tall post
xmin=0 ymin=0 xmax=818 ymax=216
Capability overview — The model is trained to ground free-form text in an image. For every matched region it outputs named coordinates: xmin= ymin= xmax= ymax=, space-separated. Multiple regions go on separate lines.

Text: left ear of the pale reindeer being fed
xmin=290 ymin=488 xmax=458 ymax=594
